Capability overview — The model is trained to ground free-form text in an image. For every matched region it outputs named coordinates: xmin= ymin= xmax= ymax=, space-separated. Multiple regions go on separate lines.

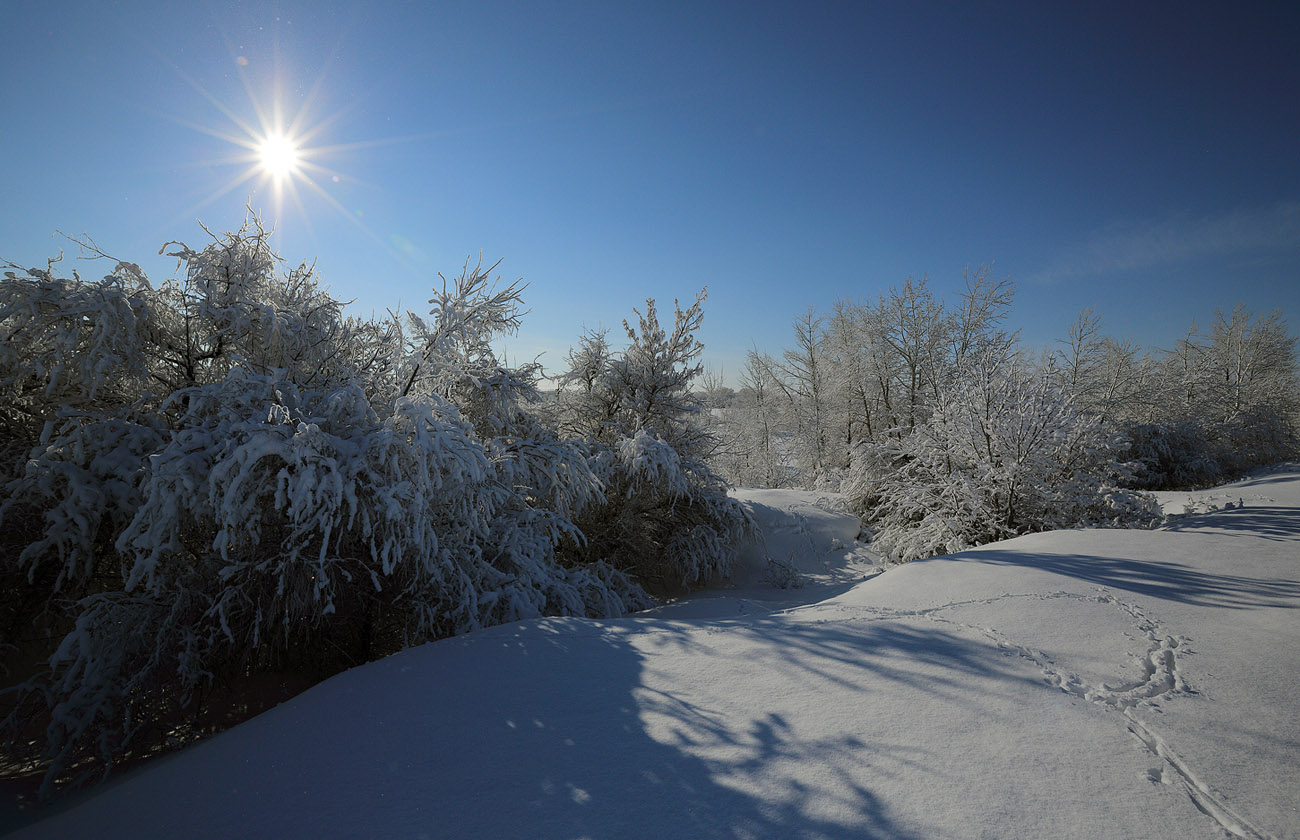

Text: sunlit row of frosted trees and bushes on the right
xmin=711 ymin=268 xmax=1300 ymax=559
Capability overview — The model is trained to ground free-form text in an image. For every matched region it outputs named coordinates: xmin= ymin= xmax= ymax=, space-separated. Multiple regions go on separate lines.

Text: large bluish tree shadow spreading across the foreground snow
xmin=17 ymin=618 xmax=1041 ymax=840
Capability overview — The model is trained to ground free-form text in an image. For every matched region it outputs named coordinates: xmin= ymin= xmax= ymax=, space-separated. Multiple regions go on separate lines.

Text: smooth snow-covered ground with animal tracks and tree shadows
xmin=16 ymin=467 xmax=1300 ymax=839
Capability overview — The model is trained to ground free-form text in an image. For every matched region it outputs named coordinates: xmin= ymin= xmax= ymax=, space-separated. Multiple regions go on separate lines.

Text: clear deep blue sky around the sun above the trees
xmin=0 ymin=0 xmax=1300 ymax=378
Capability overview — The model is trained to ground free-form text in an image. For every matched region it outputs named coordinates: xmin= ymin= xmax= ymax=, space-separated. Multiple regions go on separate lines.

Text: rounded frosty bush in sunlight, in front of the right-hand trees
xmin=844 ymin=354 xmax=1158 ymax=560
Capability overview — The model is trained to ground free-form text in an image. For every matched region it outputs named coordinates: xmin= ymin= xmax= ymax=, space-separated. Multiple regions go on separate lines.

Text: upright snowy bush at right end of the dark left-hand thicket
xmin=556 ymin=293 xmax=751 ymax=593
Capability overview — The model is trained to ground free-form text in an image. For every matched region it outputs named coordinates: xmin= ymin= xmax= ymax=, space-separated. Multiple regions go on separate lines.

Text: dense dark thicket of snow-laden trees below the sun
xmin=0 ymin=221 xmax=750 ymax=792
